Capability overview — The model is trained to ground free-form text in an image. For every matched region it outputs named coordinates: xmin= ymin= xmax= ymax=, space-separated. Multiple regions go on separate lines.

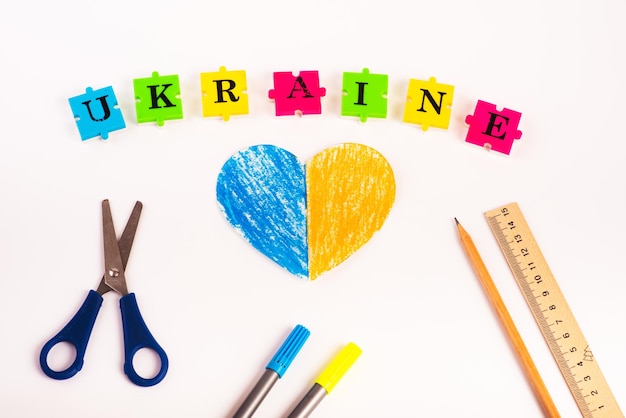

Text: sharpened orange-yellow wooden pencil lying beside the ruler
xmin=454 ymin=218 xmax=560 ymax=418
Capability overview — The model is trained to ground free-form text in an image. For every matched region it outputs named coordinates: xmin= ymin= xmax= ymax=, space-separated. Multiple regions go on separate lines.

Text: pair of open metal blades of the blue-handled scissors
xmin=98 ymin=200 xmax=142 ymax=295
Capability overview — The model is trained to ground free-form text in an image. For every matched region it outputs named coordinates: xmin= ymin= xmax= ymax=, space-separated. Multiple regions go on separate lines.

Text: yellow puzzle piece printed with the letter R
xmin=200 ymin=67 xmax=248 ymax=121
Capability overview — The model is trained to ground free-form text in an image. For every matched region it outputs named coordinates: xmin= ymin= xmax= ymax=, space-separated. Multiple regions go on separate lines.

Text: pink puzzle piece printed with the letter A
xmin=268 ymin=71 xmax=326 ymax=116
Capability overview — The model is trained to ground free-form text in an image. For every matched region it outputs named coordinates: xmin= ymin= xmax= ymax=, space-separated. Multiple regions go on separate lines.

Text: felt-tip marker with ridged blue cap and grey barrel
xmin=233 ymin=325 xmax=311 ymax=418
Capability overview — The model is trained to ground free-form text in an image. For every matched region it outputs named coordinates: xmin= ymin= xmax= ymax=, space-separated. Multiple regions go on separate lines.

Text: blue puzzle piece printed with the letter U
xmin=68 ymin=86 xmax=126 ymax=141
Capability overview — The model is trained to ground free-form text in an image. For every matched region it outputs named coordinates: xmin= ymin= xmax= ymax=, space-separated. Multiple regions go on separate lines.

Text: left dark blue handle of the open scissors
xmin=39 ymin=290 xmax=102 ymax=380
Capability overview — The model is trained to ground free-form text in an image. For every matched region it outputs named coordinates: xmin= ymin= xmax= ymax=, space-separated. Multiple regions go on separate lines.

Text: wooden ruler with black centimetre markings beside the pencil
xmin=485 ymin=203 xmax=624 ymax=418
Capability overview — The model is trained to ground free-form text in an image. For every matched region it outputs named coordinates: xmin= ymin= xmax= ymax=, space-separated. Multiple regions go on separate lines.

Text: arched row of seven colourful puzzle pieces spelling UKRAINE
xmin=69 ymin=67 xmax=522 ymax=154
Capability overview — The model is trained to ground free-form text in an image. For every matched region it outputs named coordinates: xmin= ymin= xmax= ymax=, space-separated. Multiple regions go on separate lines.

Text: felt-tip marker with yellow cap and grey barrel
xmin=288 ymin=343 xmax=361 ymax=418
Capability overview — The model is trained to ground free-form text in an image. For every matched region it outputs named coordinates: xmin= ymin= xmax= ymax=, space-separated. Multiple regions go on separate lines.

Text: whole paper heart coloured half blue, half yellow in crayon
xmin=216 ymin=143 xmax=396 ymax=280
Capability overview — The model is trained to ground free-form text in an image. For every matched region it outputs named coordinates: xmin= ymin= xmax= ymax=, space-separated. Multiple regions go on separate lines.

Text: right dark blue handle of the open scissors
xmin=120 ymin=293 xmax=169 ymax=386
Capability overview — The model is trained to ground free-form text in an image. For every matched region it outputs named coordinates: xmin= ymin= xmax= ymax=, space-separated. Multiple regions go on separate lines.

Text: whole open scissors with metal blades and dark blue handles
xmin=39 ymin=200 xmax=169 ymax=387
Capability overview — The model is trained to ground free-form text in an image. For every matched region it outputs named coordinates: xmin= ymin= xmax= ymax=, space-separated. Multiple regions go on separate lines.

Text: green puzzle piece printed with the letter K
xmin=133 ymin=71 xmax=183 ymax=126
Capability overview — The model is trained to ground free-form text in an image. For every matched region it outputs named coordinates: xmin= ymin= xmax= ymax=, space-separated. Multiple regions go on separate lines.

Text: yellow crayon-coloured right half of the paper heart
xmin=306 ymin=143 xmax=396 ymax=280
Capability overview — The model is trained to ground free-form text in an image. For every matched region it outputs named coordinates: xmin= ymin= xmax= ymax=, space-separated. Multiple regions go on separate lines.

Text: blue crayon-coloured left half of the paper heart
xmin=216 ymin=145 xmax=308 ymax=277
